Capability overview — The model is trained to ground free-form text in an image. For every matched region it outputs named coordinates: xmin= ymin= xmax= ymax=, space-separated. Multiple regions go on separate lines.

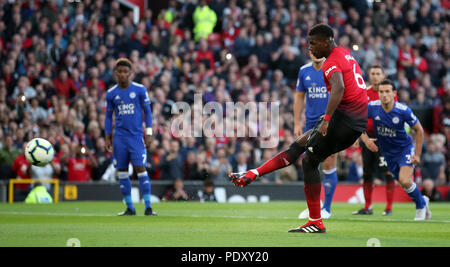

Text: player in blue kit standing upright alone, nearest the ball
xmin=105 ymin=58 xmax=156 ymax=216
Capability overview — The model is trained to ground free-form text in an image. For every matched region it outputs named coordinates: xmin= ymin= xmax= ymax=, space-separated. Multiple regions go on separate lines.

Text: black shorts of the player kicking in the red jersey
xmin=306 ymin=111 xmax=362 ymax=162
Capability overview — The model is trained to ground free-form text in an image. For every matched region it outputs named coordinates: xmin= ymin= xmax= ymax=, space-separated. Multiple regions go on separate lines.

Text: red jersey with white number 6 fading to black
xmin=322 ymin=47 xmax=368 ymax=132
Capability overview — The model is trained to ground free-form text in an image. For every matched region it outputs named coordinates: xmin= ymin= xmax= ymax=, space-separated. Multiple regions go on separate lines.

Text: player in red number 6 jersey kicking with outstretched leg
xmin=230 ymin=24 xmax=368 ymax=233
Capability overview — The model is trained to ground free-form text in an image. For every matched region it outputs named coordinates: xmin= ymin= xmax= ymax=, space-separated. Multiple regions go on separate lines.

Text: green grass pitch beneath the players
xmin=0 ymin=201 xmax=450 ymax=247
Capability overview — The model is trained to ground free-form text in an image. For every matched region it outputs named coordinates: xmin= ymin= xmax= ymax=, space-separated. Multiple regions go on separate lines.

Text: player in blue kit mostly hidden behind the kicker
xmin=294 ymin=52 xmax=337 ymax=219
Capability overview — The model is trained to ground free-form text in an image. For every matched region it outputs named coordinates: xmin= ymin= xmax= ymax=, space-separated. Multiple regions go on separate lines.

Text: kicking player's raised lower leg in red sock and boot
xmin=229 ymin=130 xmax=312 ymax=187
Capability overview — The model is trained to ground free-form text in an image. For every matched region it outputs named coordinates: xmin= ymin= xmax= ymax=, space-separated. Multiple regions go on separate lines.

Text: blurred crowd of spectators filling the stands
xmin=0 ymin=0 xmax=450 ymax=197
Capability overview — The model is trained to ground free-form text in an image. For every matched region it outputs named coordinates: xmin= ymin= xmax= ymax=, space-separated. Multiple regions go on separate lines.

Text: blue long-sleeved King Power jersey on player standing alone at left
xmin=105 ymin=82 xmax=151 ymax=136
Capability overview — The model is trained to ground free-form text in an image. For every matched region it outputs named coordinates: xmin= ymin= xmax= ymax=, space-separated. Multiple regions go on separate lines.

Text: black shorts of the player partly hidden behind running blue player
xmin=359 ymin=141 xmax=389 ymax=178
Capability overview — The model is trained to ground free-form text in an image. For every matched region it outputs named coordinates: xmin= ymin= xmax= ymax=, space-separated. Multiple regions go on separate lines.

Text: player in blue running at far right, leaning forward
xmin=361 ymin=80 xmax=431 ymax=221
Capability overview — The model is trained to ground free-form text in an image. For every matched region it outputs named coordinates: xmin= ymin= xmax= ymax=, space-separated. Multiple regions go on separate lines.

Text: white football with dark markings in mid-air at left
xmin=25 ymin=138 xmax=55 ymax=167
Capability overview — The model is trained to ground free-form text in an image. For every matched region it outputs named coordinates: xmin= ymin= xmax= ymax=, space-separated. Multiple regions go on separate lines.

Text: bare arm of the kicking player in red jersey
xmin=318 ymin=72 xmax=345 ymax=136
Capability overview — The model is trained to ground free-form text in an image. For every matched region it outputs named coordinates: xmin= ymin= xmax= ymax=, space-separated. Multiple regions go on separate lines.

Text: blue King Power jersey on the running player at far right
xmin=369 ymin=100 xmax=418 ymax=158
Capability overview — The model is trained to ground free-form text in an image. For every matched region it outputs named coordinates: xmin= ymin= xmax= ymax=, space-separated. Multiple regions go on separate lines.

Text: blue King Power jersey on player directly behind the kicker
xmin=297 ymin=62 xmax=329 ymax=121
